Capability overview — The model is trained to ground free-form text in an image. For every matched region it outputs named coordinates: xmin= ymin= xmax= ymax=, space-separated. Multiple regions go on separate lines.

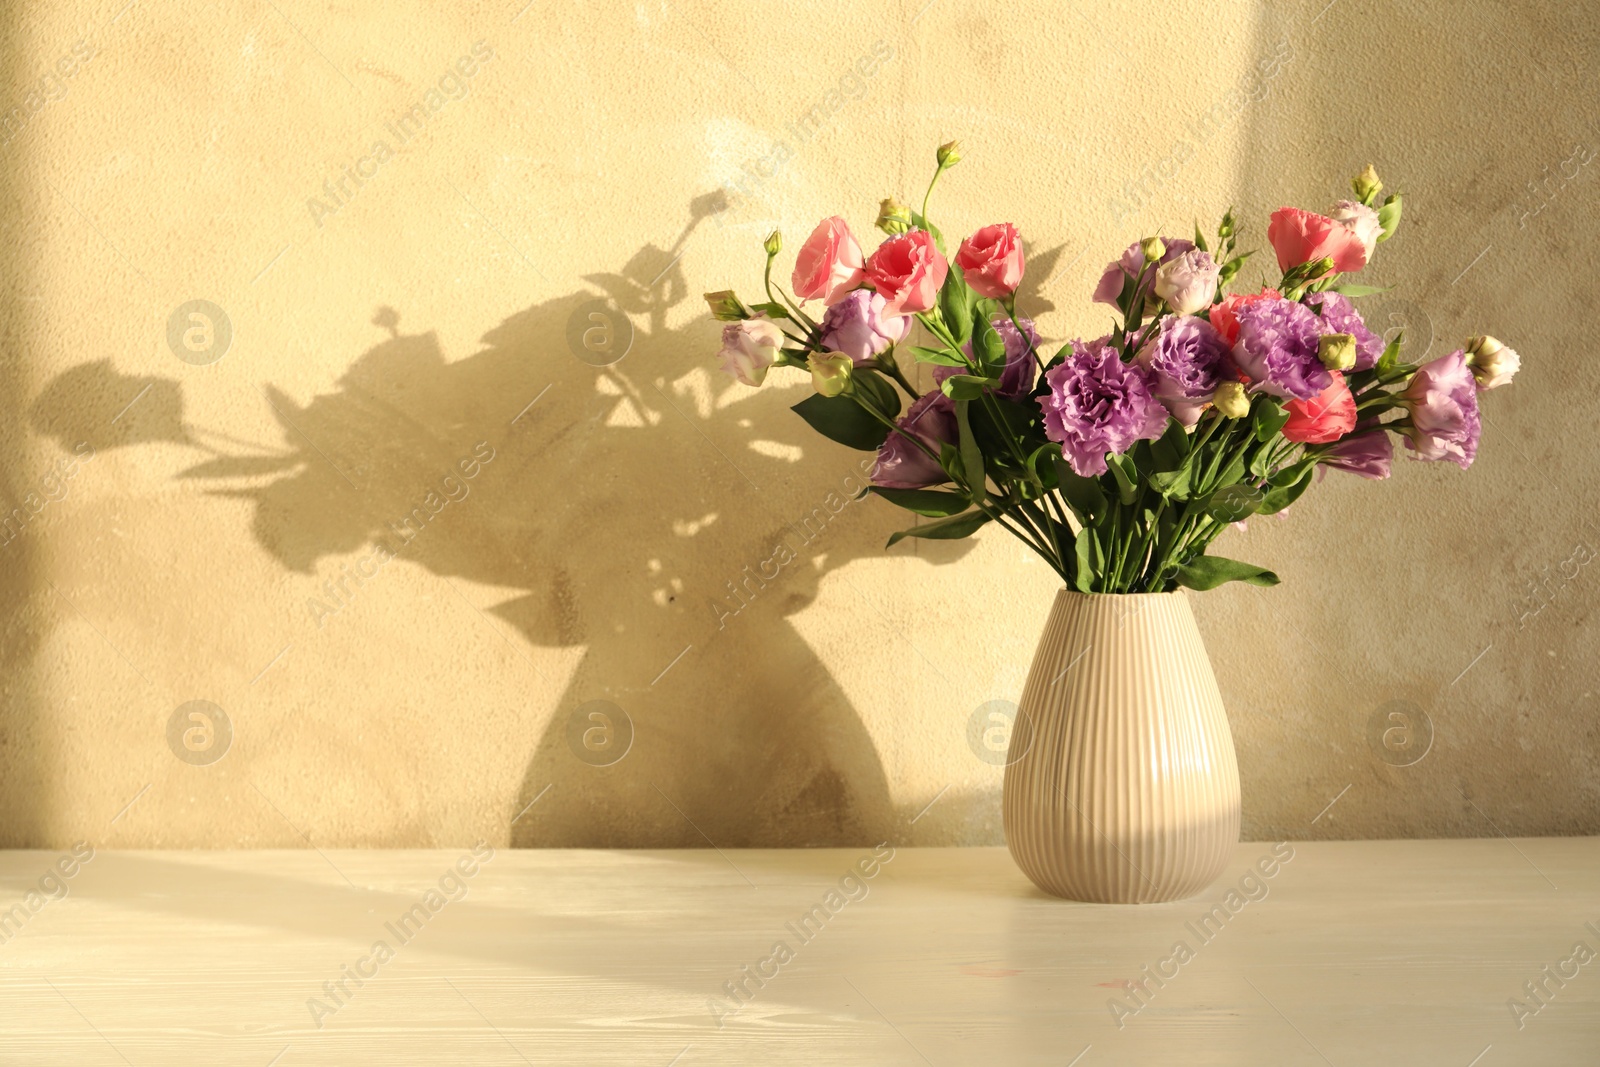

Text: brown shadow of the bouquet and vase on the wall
xmin=21 ymin=194 xmax=1059 ymax=848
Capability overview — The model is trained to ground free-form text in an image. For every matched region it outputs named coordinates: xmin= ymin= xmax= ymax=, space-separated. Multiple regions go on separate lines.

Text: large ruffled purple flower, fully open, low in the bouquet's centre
xmin=1038 ymin=338 xmax=1166 ymax=478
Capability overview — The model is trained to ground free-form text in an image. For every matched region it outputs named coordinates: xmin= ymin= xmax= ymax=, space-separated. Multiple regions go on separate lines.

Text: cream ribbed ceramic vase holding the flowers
xmin=1005 ymin=589 xmax=1238 ymax=904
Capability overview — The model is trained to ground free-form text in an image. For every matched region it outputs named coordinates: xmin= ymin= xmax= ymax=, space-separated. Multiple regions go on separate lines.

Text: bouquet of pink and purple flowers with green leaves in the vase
xmin=706 ymin=142 xmax=1520 ymax=593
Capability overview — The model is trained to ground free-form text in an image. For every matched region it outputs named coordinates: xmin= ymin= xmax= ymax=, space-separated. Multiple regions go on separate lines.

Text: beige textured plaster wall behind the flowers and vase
xmin=0 ymin=0 xmax=1600 ymax=846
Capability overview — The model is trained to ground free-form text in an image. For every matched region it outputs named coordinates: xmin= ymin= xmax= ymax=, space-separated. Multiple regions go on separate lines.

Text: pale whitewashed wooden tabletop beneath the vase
xmin=0 ymin=838 xmax=1600 ymax=1067
